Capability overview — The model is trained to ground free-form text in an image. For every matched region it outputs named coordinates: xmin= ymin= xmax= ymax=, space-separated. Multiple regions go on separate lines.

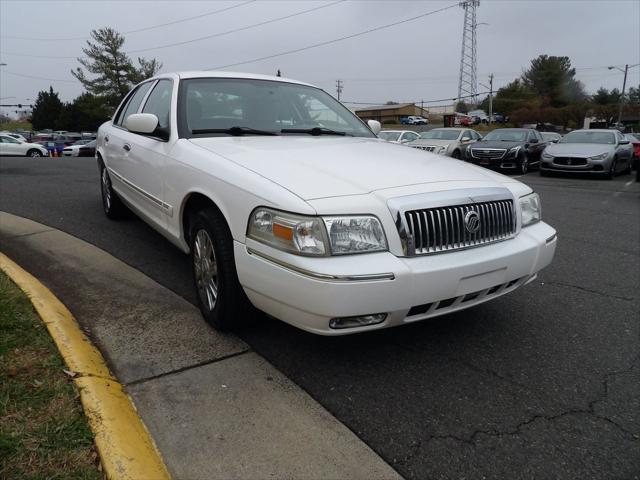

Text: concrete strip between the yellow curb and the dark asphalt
xmin=0 ymin=212 xmax=399 ymax=479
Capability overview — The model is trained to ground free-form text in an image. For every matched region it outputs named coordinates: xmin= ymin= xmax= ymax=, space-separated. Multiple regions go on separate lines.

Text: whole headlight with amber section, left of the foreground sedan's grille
xmin=247 ymin=208 xmax=387 ymax=256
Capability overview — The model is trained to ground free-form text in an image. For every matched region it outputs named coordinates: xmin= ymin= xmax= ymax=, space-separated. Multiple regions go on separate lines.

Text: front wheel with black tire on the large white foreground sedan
xmin=189 ymin=207 xmax=256 ymax=331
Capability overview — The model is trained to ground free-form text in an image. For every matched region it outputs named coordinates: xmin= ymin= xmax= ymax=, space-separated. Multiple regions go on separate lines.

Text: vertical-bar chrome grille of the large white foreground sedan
xmin=404 ymin=200 xmax=516 ymax=255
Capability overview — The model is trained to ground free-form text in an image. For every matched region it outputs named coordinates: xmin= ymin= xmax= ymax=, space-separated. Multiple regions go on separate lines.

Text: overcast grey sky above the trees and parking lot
xmin=0 ymin=0 xmax=640 ymax=113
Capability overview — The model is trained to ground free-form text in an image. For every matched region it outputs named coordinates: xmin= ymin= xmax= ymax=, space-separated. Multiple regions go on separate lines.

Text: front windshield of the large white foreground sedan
xmin=179 ymin=78 xmax=374 ymax=137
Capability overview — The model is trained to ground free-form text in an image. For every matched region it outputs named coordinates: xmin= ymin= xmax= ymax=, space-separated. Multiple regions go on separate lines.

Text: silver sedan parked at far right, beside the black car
xmin=540 ymin=129 xmax=633 ymax=179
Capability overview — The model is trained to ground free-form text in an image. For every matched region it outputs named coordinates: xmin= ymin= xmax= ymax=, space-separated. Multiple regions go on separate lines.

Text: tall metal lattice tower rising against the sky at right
xmin=458 ymin=0 xmax=480 ymax=103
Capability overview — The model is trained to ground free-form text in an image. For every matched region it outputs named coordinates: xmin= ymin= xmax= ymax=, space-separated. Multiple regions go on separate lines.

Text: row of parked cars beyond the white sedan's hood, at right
xmin=378 ymin=128 xmax=640 ymax=178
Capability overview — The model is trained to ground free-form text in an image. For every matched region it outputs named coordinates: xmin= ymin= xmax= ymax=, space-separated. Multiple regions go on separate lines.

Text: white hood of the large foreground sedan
xmin=190 ymin=136 xmax=508 ymax=200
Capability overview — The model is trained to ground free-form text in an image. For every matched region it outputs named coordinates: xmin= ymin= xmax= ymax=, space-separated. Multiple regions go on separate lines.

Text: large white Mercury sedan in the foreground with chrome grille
xmin=97 ymin=72 xmax=556 ymax=335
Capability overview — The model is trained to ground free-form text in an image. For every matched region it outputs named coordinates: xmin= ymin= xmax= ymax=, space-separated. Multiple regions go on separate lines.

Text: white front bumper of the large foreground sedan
xmin=234 ymin=222 xmax=557 ymax=335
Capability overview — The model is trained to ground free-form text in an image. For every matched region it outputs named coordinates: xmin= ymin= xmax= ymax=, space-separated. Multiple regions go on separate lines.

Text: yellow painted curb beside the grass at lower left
xmin=0 ymin=253 xmax=171 ymax=480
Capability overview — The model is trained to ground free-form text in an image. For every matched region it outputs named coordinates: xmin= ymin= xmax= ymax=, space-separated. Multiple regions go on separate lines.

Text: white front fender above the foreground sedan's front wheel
xmin=164 ymin=137 xmax=316 ymax=251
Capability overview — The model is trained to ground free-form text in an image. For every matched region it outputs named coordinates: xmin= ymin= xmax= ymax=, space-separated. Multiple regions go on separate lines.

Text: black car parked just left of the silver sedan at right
xmin=465 ymin=128 xmax=548 ymax=174
